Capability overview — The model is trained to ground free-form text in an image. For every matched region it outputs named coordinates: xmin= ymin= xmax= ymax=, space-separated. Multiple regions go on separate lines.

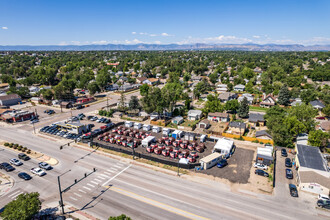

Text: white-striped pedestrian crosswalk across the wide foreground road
xmin=68 ymin=162 xmax=128 ymax=201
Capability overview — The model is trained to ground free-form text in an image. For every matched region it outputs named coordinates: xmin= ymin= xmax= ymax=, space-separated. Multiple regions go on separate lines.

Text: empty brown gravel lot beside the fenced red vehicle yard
xmin=200 ymin=146 xmax=254 ymax=184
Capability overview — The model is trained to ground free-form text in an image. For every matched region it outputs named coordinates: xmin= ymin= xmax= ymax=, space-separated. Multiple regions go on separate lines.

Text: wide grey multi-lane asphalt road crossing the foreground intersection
xmin=0 ymin=128 xmax=329 ymax=219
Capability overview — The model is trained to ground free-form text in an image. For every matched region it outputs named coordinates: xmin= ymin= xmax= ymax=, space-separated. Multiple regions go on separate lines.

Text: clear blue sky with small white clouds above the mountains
xmin=0 ymin=0 xmax=330 ymax=45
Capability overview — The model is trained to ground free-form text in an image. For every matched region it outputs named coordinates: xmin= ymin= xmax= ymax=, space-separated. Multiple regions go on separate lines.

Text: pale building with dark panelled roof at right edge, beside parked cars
xmin=295 ymin=144 xmax=330 ymax=195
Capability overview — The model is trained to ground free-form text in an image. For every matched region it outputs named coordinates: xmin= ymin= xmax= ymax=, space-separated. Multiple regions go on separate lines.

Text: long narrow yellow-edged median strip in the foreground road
xmin=108 ymin=186 xmax=209 ymax=220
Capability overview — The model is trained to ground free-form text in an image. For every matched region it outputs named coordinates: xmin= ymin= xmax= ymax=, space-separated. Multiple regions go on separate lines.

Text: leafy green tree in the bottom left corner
xmin=1 ymin=192 xmax=41 ymax=220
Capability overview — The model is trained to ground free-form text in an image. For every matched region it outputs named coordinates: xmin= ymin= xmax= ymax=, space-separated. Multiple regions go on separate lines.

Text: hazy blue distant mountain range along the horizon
xmin=0 ymin=44 xmax=330 ymax=51
